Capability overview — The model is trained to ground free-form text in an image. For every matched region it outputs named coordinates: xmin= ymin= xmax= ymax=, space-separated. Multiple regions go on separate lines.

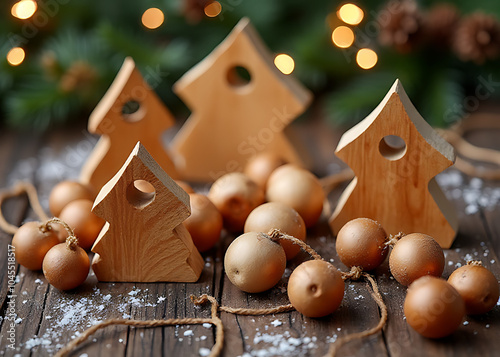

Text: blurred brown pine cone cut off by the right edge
xmin=454 ymin=12 xmax=500 ymax=64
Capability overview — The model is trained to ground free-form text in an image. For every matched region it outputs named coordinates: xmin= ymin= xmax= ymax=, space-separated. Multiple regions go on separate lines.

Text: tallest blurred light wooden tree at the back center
xmin=172 ymin=18 xmax=311 ymax=181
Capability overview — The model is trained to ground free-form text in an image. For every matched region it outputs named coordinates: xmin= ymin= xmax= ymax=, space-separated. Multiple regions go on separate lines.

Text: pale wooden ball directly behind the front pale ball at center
xmin=244 ymin=202 xmax=306 ymax=260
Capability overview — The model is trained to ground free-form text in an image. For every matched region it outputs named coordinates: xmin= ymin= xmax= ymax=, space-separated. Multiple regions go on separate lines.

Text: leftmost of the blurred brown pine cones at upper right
xmin=378 ymin=0 xmax=423 ymax=52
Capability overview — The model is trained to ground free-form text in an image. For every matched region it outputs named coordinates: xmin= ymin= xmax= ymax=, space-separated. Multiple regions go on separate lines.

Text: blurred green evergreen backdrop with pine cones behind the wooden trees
xmin=0 ymin=0 xmax=500 ymax=130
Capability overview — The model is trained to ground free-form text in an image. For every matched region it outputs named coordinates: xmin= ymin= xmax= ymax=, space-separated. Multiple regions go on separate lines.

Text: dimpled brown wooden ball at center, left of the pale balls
xmin=208 ymin=172 xmax=264 ymax=232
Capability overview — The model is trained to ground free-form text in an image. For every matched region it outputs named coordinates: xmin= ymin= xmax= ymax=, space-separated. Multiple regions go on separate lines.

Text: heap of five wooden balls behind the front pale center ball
xmin=184 ymin=153 xmax=325 ymax=254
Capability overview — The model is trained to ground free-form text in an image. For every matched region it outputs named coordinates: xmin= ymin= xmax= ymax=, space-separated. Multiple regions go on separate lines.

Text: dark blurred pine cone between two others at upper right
xmin=425 ymin=3 xmax=460 ymax=48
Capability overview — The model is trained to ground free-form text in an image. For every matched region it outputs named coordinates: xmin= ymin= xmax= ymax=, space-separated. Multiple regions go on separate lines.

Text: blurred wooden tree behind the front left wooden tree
xmin=80 ymin=57 xmax=178 ymax=192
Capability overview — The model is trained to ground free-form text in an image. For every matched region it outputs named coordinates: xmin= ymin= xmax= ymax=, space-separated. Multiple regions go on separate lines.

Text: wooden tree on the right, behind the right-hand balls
xmin=330 ymin=80 xmax=458 ymax=248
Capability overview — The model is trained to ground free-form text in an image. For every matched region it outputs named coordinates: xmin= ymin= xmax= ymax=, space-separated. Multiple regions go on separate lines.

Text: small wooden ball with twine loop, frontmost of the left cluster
xmin=43 ymin=243 xmax=90 ymax=290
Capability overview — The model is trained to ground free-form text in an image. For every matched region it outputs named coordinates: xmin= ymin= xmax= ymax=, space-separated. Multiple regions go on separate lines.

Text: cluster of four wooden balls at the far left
xmin=12 ymin=181 xmax=104 ymax=290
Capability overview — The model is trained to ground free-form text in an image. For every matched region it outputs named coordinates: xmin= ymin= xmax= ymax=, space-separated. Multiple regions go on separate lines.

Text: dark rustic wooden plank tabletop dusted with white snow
xmin=0 ymin=115 xmax=500 ymax=357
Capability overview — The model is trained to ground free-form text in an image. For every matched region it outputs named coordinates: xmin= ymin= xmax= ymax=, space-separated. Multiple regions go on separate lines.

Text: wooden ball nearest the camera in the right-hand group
xmin=404 ymin=276 xmax=465 ymax=338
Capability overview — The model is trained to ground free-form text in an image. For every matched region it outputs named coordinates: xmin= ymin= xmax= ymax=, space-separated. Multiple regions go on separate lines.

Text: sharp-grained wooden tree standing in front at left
xmin=92 ymin=143 xmax=204 ymax=282
